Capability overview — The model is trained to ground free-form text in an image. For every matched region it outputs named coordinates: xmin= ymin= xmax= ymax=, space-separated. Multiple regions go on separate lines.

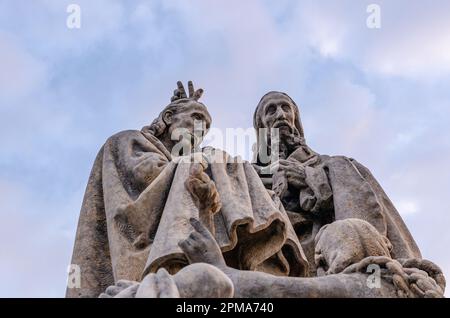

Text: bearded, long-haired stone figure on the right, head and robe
xmin=253 ymin=92 xmax=420 ymax=275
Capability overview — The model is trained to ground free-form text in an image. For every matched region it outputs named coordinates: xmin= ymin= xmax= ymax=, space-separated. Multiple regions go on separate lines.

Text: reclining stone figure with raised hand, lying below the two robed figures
xmin=101 ymin=219 xmax=445 ymax=298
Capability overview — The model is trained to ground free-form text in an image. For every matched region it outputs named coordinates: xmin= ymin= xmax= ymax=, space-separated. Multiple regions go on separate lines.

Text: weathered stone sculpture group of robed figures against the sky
xmin=67 ymin=82 xmax=445 ymax=298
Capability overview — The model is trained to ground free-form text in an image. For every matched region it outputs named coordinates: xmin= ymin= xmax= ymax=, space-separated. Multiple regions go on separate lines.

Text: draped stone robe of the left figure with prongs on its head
xmin=66 ymin=127 xmax=308 ymax=297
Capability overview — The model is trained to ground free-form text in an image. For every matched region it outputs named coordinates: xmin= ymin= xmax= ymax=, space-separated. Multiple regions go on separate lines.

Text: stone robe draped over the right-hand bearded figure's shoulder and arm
xmin=270 ymin=145 xmax=421 ymax=276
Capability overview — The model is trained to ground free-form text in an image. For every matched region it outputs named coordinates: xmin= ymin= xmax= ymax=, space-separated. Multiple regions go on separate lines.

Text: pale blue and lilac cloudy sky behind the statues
xmin=0 ymin=0 xmax=450 ymax=297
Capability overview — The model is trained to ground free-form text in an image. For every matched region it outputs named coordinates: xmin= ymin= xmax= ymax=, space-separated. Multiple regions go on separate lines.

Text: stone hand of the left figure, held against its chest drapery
xmin=185 ymin=162 xmax=222 ymax=234
